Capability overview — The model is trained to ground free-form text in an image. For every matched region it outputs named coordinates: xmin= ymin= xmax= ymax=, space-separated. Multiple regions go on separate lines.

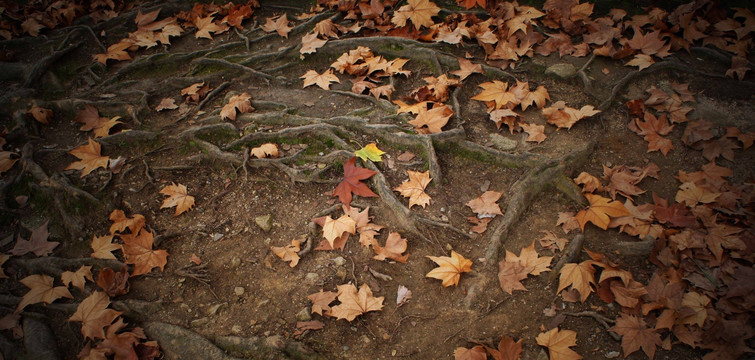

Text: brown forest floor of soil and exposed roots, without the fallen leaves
xmin=0 ymin=2 xmax=755 ymax=359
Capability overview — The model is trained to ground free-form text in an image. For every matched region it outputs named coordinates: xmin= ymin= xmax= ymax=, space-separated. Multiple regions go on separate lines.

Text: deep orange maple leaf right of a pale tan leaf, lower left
xmin=119 ymin=229 xmax=168 ymax=276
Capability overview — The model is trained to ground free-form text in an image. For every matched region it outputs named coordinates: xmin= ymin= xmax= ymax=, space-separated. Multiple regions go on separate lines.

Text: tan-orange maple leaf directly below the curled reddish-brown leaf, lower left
xmin=68 ymin=291 xmax=121 ymax=340
